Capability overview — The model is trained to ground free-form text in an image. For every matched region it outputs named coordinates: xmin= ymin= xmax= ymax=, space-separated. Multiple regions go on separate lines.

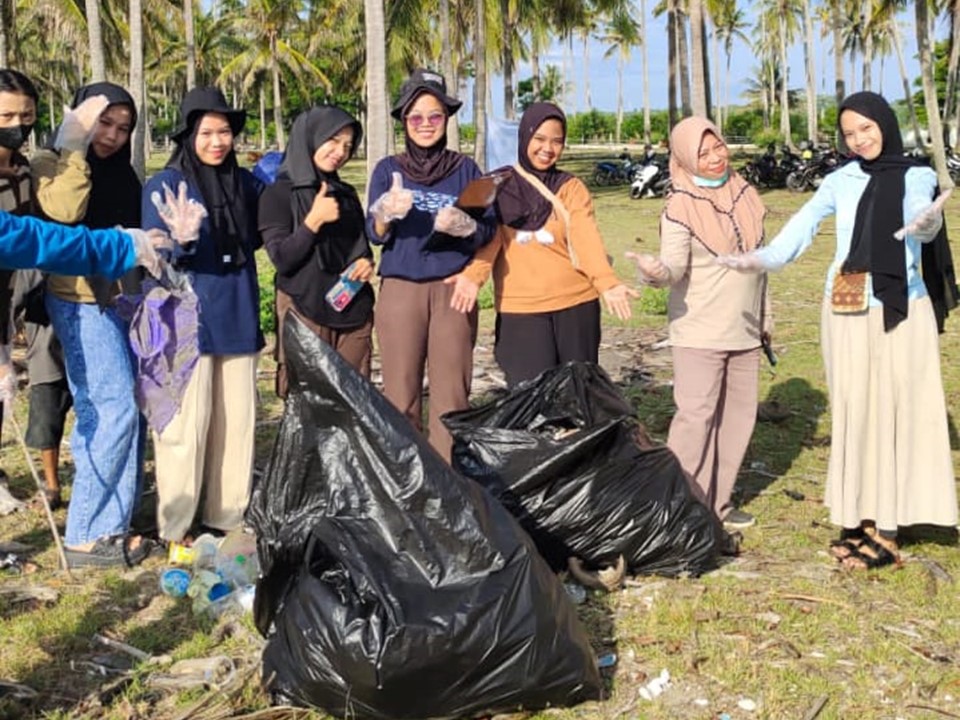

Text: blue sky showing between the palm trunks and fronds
xmin=461 ymin=0 xmax=948 ymax=118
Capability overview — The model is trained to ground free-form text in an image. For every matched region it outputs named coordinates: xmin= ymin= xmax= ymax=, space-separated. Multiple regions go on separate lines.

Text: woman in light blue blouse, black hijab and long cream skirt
xmin=722 ymin=92 xmax=957 ymax=568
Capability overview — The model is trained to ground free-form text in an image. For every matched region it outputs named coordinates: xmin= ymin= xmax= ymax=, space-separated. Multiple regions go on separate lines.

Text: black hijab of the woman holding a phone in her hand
xmin=278 ymin=105 xmax=363 ymax=227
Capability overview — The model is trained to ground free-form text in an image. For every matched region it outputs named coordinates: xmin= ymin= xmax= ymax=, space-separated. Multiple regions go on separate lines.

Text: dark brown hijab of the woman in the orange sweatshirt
xmin=496 ymin=102 xmax=573 ymax=230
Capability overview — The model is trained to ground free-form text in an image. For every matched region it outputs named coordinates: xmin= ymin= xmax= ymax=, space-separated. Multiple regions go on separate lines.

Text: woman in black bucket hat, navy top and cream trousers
xmin=142 ymin=88 xmax=263 ymax=540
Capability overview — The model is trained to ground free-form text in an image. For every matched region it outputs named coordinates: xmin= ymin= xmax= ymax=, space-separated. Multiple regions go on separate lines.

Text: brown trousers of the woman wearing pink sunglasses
xmin=375 ymin=278 xmax=477 ymax=462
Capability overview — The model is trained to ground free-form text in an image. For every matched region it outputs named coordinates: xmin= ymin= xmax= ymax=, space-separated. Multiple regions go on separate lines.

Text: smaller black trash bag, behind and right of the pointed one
xmin=443 ymin=363 xmax=722 ymax=575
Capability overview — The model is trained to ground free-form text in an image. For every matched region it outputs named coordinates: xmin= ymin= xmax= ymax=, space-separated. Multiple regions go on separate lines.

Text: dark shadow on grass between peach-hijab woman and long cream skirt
xmin=737 ymin=378 xmax=829 ymax=504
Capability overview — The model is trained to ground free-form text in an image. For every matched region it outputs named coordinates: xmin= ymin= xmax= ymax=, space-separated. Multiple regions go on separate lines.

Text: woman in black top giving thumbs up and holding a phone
xmin=259 ymin=105 xmax=373 ymax=390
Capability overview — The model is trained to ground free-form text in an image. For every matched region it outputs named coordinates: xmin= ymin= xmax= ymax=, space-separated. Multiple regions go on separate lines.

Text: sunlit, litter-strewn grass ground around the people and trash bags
xmin=0 ymin=148 xmax=960 ymax=720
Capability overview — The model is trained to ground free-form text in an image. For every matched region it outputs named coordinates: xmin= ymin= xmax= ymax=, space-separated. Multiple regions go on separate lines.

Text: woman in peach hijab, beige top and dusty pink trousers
xmin=633 ymin=117 xmax=766 ymax=528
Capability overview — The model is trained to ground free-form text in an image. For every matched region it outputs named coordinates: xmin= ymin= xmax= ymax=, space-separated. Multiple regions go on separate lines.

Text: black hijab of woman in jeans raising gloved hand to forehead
xmin=71 ymin=82 xmax=141 ymax=228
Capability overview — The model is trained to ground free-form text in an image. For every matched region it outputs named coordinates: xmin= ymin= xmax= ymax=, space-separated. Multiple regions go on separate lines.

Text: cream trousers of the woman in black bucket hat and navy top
xmin=154 ymin=354 xmax=257 ymax=540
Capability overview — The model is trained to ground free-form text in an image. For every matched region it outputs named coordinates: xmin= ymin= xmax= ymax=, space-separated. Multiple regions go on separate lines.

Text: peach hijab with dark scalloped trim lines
xmin=663 ymin=117 xmax=766 ymax=255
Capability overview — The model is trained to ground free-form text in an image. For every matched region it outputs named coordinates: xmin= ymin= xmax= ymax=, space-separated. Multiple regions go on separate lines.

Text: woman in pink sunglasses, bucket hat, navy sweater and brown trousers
xmin=367 ymin=70 xmax=495 ymax=460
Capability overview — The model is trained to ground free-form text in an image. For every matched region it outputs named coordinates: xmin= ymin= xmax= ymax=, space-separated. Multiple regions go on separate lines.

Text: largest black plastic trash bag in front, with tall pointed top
xmin=247 ymin=316 xmax=601 ymax=718
